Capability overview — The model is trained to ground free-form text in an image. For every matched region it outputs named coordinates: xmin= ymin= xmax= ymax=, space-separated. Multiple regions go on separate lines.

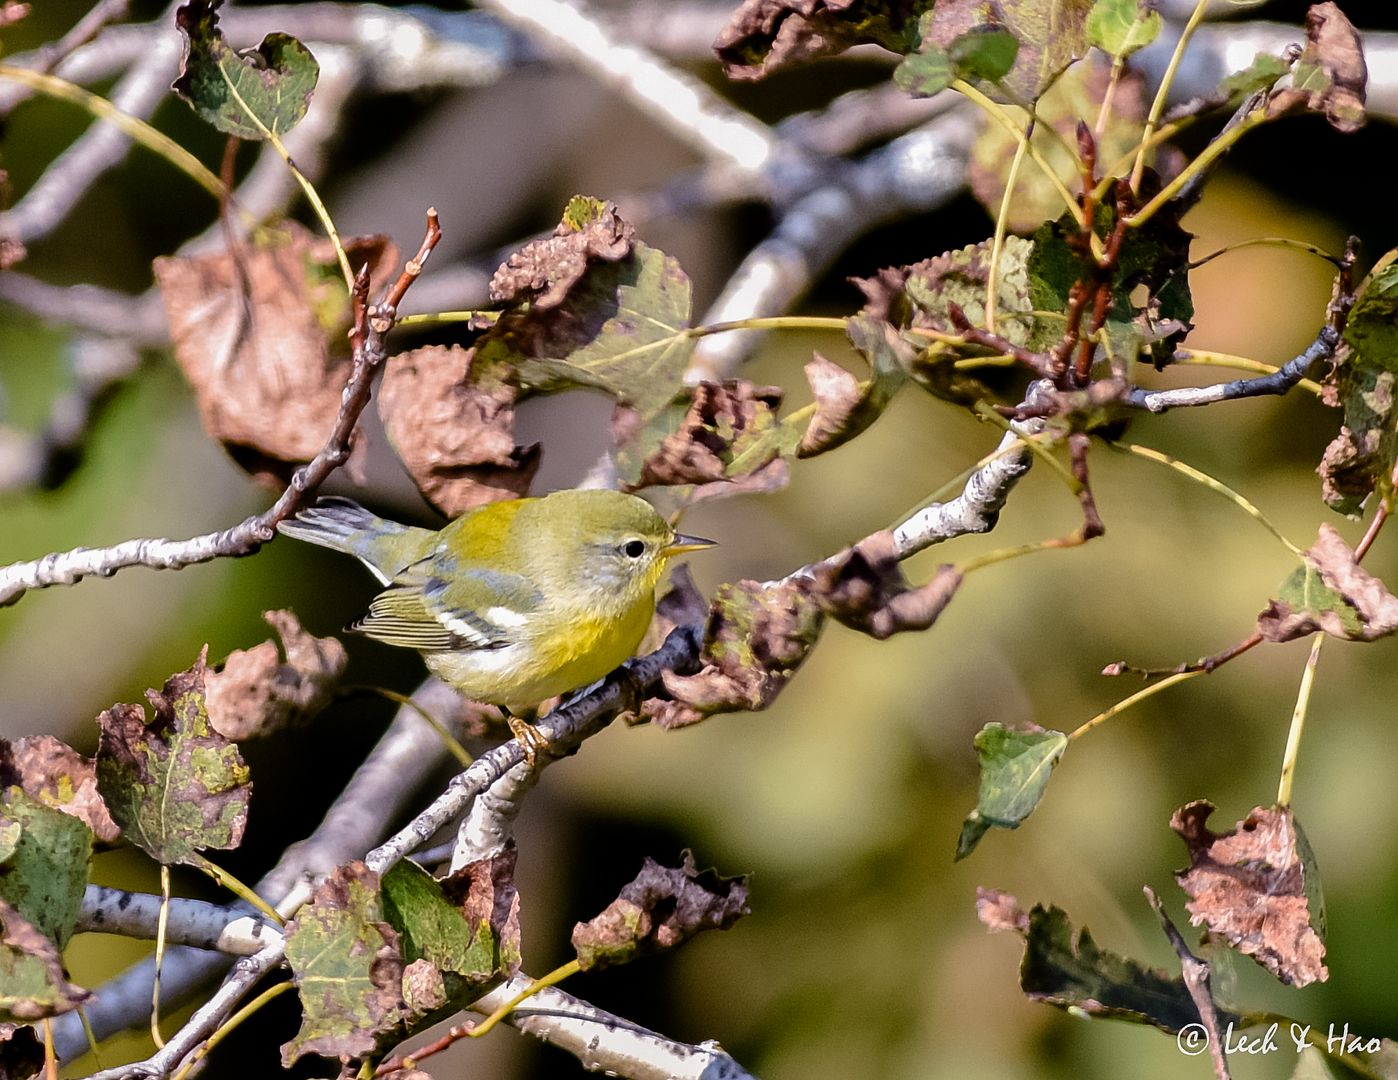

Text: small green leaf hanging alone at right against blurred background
xmin=956 ymin=722 xmax=1068 ymax=859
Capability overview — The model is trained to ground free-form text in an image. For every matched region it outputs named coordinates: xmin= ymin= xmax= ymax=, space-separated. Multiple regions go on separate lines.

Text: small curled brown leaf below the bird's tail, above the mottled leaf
xmin=204 ymin=611 xmax=350 ymax=742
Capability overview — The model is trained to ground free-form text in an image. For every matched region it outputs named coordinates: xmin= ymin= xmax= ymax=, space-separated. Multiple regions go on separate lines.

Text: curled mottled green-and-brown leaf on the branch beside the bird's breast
xmin=642 ymin=578 xmax=823 ymax=728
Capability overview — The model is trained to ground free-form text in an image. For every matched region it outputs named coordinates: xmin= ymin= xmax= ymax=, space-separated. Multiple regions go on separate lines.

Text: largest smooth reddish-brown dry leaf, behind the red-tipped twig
xmin=155 ymin=225 xmax=397 ymax=486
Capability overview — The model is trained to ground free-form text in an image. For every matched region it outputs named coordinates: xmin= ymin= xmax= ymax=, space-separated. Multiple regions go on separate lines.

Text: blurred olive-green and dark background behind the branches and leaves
xmin=0 ymin=0 xmax=1398 ymax=1080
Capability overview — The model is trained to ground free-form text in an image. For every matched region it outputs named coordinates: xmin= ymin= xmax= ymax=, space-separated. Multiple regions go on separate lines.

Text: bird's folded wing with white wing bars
xmin=350 ymin=559 xmax=542 ymax=652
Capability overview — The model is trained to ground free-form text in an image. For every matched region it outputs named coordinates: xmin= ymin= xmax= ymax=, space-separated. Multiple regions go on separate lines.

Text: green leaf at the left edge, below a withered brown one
xmin=0 ymin=788 xmax=92 ymax=949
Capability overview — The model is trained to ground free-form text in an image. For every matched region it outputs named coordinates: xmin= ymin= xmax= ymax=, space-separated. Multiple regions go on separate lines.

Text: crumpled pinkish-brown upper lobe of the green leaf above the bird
xmin=491 ymin=196 xmax=636 ymax=307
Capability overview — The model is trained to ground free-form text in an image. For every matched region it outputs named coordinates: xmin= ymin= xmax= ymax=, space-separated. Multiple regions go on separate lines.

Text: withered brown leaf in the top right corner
xmin=1268 ymin=3 xmax=1369 ymax=133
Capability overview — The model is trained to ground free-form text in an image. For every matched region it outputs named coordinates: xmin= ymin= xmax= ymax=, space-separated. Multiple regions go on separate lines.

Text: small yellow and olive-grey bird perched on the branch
xmin=277 ymin=490 xmax=713 ymax=760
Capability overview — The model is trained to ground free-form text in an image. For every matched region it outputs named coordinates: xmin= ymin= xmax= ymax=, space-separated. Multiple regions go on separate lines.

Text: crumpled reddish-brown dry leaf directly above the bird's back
xmin=379 ymin=345 xmax=540 ymax=518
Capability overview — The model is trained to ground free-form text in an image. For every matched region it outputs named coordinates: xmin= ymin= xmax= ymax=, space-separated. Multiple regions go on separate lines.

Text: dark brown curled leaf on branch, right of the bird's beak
xmin=815 ymin=530 xmax=962 ymax=640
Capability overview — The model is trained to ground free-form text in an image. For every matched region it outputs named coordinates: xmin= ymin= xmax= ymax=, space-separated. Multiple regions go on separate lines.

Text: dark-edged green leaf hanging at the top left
xmin=173 ymin=0 xmax=320 ymax=140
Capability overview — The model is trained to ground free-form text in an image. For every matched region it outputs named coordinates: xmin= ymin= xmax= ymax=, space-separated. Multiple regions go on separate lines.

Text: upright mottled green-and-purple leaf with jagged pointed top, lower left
xmin=96 ymin=648 xmax=252 ymax=865
